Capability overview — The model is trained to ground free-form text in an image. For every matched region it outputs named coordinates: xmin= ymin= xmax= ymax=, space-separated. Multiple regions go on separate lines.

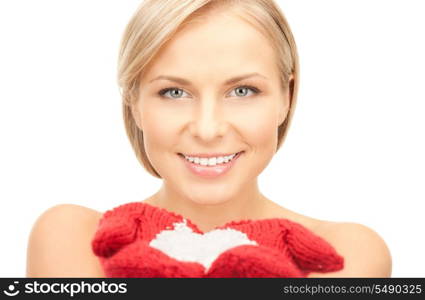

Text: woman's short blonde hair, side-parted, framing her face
xmin=118 ymin=0 xmax=299 ymax=178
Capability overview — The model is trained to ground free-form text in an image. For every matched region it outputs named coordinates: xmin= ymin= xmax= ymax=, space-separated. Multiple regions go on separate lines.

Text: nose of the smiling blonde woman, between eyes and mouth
xmin=189 ymin=97 xmax=228 ymax=142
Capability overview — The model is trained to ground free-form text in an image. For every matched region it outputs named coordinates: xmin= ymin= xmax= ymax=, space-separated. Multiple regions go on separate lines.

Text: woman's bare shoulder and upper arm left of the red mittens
xmin=26 ymin=204 xmax=104 ymax=277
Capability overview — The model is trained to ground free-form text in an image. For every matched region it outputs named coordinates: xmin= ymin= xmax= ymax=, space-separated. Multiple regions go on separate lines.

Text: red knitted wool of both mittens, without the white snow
xmin=91 ymin=202 xmax=344 ymax=278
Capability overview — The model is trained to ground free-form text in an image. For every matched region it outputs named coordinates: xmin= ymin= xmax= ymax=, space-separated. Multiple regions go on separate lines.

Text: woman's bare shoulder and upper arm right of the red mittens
xmin=310 ymin=220 xmax=392 ymax=277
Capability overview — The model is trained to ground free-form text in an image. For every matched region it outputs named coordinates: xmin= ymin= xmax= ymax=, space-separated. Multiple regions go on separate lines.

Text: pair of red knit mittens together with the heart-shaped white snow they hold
xmin=92 ymin=202 xmax=343 ymax=278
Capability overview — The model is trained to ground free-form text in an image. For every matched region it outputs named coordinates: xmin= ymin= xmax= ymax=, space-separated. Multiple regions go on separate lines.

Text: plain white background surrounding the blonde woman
xmin=0 ymin=0 xmax=425 ymax=277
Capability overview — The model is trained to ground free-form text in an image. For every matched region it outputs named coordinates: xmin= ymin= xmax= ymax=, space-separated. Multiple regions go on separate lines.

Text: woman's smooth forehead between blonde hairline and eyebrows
xmin=142 ymin=12 xmax=276 ymax=80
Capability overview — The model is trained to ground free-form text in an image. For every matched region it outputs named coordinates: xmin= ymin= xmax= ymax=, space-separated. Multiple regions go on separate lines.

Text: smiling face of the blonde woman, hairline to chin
xmin=133 ymin=13 xmax=289 ymax=204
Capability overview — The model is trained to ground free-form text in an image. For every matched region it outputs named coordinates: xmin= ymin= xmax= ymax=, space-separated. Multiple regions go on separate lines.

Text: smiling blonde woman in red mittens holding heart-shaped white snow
xmin=27 ymin=0 xmax=391 ymax=277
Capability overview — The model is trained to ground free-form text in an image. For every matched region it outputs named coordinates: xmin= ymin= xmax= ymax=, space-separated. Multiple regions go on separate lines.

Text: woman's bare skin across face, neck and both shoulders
xmin=27 ymin=8 xmax=392 ymax=277
